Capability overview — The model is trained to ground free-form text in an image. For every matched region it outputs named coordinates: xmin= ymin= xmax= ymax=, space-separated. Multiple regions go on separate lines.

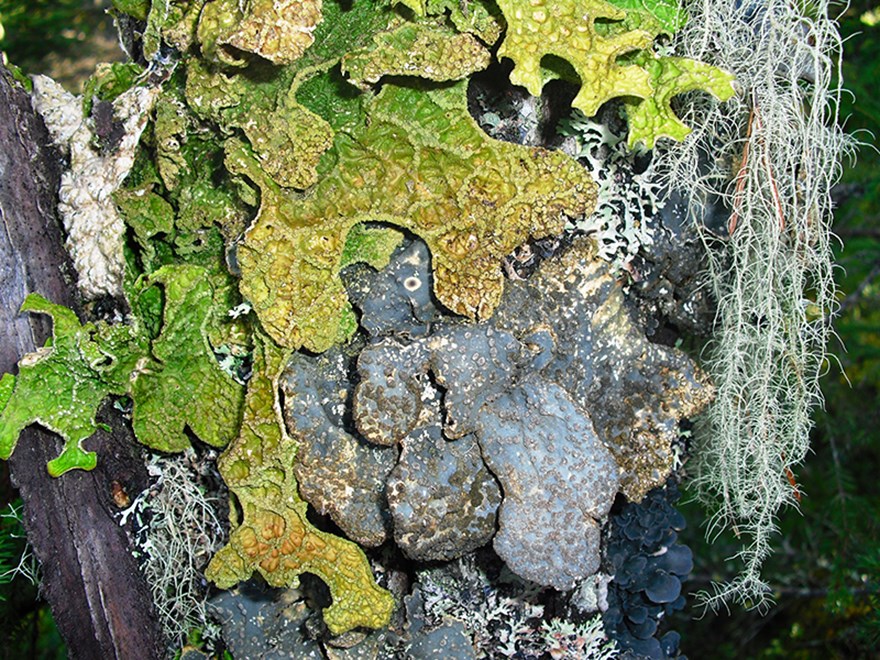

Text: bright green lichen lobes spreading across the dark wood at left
xmin=0 ymin=266 xmax=243 ymax=476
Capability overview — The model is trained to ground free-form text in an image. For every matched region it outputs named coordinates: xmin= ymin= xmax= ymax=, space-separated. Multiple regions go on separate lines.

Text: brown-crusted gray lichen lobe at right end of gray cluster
xmin=494 ymin=238 xmax=712 ymax=501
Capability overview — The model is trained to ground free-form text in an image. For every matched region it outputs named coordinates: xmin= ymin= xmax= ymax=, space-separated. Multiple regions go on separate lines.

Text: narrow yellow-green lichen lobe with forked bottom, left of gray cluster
xmin=205 ymin=335 xmax=394 ymax=634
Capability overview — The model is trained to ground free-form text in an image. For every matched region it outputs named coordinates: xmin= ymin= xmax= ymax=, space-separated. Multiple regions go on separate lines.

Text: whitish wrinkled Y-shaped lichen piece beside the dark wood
xmin=33 ymin=75 xmax=159 ymax=299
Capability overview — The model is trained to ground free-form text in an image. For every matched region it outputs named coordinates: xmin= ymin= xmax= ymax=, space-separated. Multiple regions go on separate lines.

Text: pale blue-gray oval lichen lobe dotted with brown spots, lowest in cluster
xmin=478 ymin=374 xmax=618 ymax=591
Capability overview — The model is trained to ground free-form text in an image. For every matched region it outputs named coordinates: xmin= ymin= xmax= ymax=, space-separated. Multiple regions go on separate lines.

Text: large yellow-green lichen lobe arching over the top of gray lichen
xmin=234 ymin=83 xmax=595 ymax=351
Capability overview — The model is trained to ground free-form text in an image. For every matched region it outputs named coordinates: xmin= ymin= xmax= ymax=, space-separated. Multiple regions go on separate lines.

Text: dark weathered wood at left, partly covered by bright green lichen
xmin=0 ymin=67 xmax=164 ymax=660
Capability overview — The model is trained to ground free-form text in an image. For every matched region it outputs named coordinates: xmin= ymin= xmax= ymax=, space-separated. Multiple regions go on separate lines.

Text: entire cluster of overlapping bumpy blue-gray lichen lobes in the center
xmin=284 ymin=232 xmax=710 ymax=590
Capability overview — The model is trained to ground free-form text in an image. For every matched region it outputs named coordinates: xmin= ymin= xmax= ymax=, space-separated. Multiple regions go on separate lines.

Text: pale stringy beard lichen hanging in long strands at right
xmin=658 ymin=0 xmax=851 ymax=607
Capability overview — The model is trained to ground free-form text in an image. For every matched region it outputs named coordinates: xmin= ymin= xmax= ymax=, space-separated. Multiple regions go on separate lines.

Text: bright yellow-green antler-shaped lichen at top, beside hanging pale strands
xmin=498 ymin=0 xmax=734 ymax=149
